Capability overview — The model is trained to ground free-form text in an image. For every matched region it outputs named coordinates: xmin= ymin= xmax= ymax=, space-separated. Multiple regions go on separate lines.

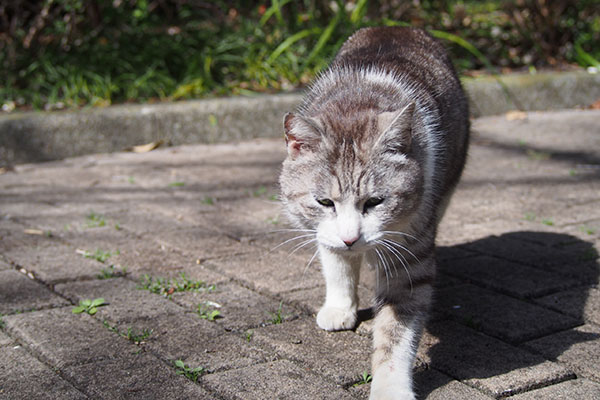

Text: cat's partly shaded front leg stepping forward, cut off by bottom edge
xmin=370 ymin=257 xmax=435 ymax=400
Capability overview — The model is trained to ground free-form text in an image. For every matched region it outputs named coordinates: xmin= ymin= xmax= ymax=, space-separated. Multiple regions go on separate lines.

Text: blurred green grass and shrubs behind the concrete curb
xmin=0 ymin=0 xmax=600 ymax=111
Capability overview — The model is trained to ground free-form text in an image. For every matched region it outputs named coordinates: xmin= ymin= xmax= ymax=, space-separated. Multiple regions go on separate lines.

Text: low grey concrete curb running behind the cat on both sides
xmin=0 ymin=71 xmax=600 ymax=166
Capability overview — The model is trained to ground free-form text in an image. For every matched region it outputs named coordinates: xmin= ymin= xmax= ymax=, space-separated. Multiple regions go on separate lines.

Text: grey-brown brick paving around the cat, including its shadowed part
xmin=0 ymin=111 xmax=600 ymax=400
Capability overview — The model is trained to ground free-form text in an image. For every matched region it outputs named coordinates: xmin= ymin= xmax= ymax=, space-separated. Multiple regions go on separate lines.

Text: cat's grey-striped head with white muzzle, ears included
xmin=280 ymin=104 xmax=424 ymax=253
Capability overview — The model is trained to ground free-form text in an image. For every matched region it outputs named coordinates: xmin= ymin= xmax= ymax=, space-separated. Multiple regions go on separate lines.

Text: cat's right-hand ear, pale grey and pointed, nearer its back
xmin=374 ymin=103 xmax=415 ymax=153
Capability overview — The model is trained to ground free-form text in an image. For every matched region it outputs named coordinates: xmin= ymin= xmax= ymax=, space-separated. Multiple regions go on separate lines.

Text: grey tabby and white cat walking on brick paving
xmin=280 ymin=28 xmax=469 ymax=399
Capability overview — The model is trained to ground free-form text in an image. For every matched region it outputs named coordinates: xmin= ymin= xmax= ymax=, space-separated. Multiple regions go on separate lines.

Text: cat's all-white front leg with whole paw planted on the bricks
xmin=317 ymin=246 xmax=362 ymax=331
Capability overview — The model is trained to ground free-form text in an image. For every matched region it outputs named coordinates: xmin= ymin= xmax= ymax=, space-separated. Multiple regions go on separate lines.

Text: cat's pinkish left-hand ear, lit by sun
xmin=283 ymin=113 xmax=321 ymax=159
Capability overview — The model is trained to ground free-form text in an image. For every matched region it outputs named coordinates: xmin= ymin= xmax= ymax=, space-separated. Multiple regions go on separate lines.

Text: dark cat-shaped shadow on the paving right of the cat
xmin=364 ymin=232 xmax=600 ymax=399
